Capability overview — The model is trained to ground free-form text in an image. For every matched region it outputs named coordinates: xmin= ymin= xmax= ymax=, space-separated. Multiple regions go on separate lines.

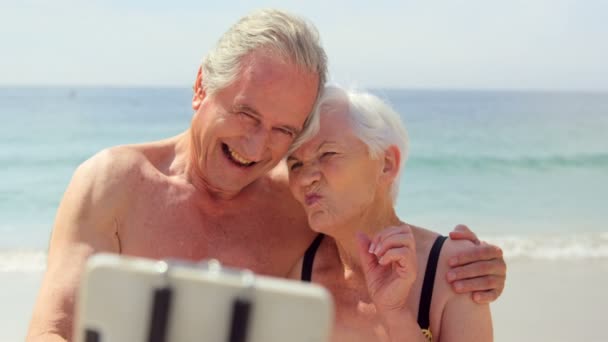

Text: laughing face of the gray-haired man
xmin=192 ymin=51 xmax=318 ymax=194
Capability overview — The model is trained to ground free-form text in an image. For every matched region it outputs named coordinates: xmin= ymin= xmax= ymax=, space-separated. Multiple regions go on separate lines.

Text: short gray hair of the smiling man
xmin=201 ymin=9 xmax=327 ymax=97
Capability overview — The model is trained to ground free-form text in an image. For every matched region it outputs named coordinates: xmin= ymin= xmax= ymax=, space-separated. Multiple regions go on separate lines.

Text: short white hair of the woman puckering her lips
xmin=289 ymin=86 xmax=409 ymax=202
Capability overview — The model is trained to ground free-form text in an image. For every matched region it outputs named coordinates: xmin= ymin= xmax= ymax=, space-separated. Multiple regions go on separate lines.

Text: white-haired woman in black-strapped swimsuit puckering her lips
xmin=287 ymin=87 xmax=492 ymax=342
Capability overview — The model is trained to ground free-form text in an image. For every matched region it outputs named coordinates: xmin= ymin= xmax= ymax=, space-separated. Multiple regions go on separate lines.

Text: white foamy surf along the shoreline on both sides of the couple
xmin=0 ymin=232 xmax=608 ymax=273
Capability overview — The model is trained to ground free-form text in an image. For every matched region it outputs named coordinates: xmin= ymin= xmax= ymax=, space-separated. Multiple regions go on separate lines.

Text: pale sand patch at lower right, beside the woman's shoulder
xmin=492 ymin=259 xmax=608 ymax=342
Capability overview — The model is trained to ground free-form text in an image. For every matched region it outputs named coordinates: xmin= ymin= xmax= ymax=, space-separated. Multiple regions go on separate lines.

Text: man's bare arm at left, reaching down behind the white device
xmin=27 ymin=151 xmax=129 ymax=341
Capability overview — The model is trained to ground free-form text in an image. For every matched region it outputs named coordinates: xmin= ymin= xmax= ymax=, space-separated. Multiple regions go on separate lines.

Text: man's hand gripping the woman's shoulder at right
xmin=446 ymin=225 xmax=507 ymax=304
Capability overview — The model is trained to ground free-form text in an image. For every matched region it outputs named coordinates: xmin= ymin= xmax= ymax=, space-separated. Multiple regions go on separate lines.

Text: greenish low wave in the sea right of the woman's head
xmin=409 ymin=153 xmax=608 ymax=171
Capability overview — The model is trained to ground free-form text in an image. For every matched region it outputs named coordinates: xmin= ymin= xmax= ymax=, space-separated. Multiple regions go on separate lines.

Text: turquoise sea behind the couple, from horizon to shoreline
xmin=0 ymin=87 xmax=608 ymax=272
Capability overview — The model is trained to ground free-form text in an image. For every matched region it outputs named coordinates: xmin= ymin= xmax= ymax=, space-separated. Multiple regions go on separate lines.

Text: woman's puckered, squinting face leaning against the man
xmin=287 ymin=105 xmax=382 ymax=233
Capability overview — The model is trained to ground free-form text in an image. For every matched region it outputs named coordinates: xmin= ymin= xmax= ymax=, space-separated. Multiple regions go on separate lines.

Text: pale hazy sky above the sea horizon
xmin=0 ymin=0 xmax=608 ymax=91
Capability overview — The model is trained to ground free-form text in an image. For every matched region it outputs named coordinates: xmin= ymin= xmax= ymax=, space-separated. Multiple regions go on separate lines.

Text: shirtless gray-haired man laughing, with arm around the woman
xmin=28 ymin=10 xmax=505 ymax=341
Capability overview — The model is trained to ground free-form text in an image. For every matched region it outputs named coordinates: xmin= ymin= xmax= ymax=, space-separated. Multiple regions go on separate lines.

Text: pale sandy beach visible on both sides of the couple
xmin=0 ymin=258 xmax=608 ymax=342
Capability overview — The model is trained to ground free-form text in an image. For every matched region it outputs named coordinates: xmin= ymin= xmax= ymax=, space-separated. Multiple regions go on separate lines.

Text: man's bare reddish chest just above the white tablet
xmin=118 ymin=194 xmax=309 ymax=275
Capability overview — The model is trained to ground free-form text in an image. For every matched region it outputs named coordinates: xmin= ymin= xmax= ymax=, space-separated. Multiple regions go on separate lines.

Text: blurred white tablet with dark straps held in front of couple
xmin=73 ymin=254 xmax=333 ymax=342
